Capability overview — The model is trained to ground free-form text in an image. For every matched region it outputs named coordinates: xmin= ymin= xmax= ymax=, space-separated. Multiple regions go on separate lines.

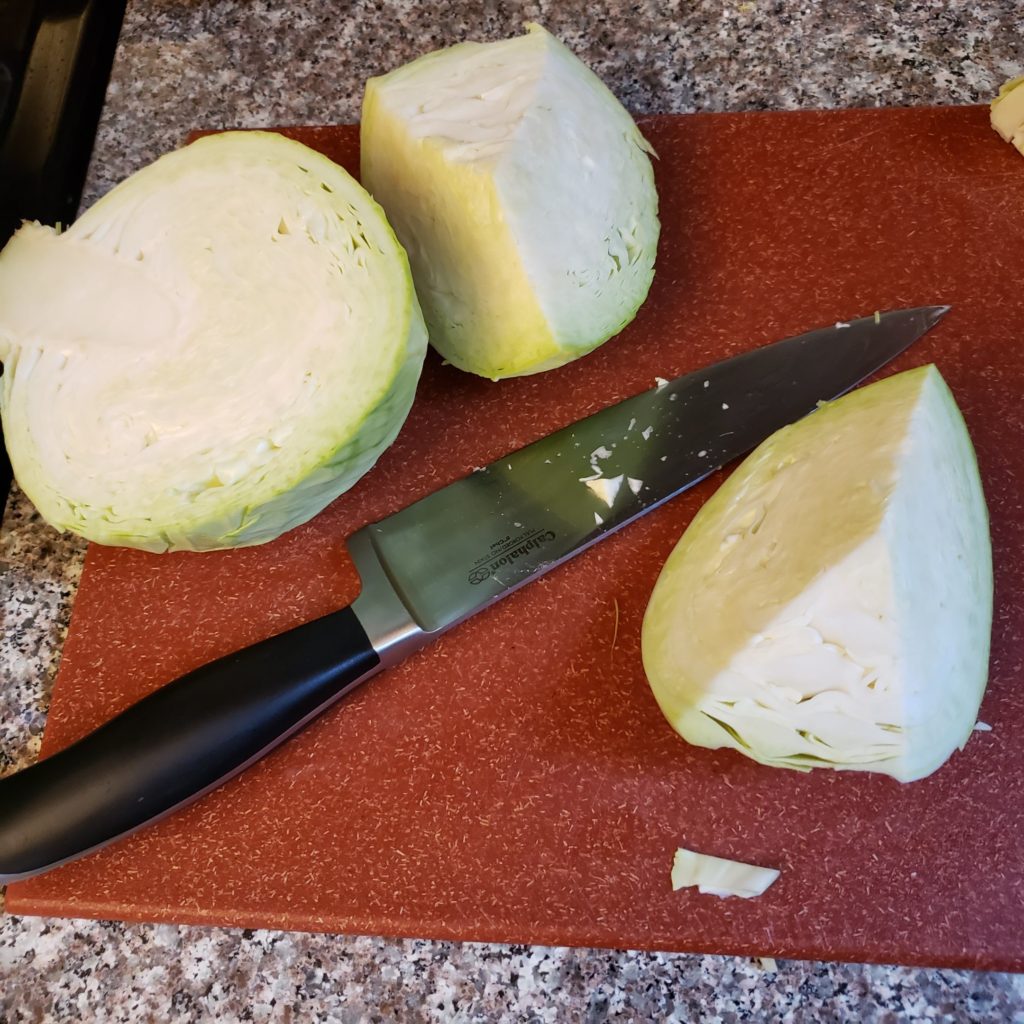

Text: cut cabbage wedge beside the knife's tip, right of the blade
xmin=642 ymin=367 xmax=992 ymax=781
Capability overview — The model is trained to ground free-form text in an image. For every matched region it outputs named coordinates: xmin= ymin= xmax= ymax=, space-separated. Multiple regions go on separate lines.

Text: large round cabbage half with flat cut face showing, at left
xmin=0 ymin=132 xmax=426 ymax=552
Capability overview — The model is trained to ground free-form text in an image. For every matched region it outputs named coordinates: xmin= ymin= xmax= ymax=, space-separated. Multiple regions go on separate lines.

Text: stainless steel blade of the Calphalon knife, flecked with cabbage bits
xmin=349 ymin=306 xmax=948 ymax=633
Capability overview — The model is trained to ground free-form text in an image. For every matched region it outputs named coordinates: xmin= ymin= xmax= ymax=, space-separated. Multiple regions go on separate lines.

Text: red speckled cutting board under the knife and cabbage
xmin=7 ymin=108 xmax=1024 ymax=970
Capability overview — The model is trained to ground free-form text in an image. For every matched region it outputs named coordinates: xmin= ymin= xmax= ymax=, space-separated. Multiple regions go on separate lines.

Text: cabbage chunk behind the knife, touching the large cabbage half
xmin=361 ymin=25 xmax=658 ymax=380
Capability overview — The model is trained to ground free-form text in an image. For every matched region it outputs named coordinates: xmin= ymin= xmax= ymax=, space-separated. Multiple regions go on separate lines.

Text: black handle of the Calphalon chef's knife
xmin=0 ymin=608 xmax=380 ymax=883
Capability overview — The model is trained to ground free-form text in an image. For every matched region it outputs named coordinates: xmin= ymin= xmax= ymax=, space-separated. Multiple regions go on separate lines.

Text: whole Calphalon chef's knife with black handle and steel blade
xmin=0 ymin=306 xmax=948 ymax=883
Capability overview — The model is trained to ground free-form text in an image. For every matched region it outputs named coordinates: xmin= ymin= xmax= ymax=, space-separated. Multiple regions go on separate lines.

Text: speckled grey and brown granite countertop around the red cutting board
xmin=0 ymin=0 xmax=1024 ymax=1022
